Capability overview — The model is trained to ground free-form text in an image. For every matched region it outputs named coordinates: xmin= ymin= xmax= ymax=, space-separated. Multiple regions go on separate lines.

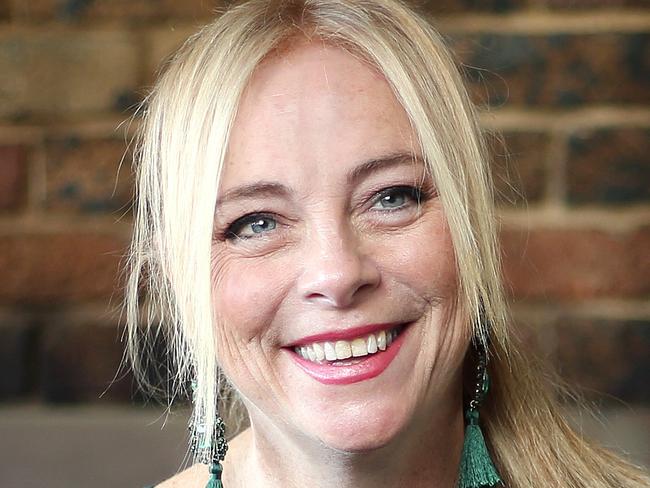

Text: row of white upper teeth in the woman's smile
xmin=295 ymin=329 xmax=398 ymax=362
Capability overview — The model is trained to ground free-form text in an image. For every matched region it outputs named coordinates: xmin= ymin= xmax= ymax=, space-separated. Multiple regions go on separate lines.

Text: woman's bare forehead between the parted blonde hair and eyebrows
xmin=222 ymin=42 xmax=414 ymax=186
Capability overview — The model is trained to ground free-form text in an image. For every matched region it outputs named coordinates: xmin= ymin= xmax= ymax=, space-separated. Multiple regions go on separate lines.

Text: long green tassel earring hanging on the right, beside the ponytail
xmin=458 ymin=346 xmax=503 ymax=488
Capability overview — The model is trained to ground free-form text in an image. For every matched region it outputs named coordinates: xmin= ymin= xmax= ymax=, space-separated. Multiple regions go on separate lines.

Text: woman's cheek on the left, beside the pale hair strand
xmin=212 ymin=248 xmax=287 ymax=344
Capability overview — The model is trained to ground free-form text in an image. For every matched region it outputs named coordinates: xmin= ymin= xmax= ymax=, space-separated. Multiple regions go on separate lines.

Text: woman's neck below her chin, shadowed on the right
xmin=224 ymin=394 xmax=464 ymax=488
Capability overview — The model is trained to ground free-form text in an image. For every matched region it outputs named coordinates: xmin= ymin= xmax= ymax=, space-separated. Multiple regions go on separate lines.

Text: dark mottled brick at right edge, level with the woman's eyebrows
xmin=567 ymin=128 xmax=650 ymax=204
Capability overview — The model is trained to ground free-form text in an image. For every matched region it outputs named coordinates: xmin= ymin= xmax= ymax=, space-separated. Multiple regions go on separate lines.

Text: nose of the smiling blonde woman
xmin=298 ymin=221 xmax=381 ymax=308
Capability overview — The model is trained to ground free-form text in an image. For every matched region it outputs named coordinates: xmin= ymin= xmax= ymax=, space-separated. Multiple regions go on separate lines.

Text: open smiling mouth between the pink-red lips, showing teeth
xmin=293 ymin=324 xmax=405 ymax=366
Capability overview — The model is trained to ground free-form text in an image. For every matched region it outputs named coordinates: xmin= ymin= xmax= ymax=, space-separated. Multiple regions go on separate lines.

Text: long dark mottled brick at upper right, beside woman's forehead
xmin=451 ymin=32 xmax=650 ymax=107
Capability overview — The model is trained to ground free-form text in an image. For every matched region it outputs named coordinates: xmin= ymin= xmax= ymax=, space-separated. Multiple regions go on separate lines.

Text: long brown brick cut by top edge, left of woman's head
xmin=12 ymin=0 xmax=223 ymax=22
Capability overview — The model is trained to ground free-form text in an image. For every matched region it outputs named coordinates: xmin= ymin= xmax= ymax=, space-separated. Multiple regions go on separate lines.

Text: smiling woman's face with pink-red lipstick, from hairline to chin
xmin=212 ymin=42 xmax=468 ymax=451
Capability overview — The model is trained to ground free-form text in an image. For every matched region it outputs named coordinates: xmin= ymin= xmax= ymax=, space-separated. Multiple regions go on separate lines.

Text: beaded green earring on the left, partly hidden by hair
xmin=190 ymin=384 xmax=228 ymax=488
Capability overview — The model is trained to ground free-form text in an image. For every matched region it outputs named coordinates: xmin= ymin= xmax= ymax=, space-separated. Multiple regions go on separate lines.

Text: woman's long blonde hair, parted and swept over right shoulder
xmin=125 ymin=0 xmax=650 ymax=488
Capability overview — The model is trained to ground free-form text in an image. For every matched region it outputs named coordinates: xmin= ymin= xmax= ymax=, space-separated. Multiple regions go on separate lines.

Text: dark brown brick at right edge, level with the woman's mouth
xmin=554 ymin=317 xmax=650 ymax=405
